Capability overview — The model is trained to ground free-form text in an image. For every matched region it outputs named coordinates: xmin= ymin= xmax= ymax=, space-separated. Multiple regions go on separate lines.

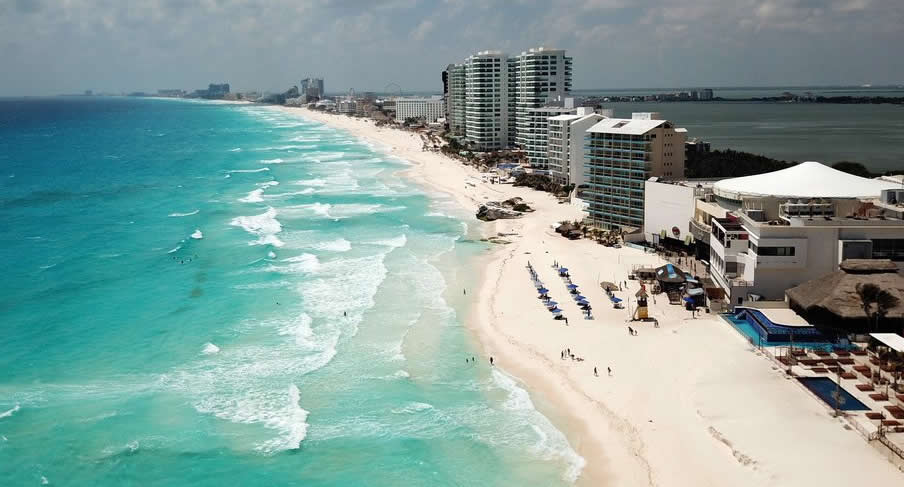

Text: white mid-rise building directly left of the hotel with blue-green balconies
xmin=546 ymin=107 xmax=612 ymax=186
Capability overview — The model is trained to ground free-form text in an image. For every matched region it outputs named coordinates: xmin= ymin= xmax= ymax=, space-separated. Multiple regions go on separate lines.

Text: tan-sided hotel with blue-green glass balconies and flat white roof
xmin=583 ymin=113 xmax=687 ymax=231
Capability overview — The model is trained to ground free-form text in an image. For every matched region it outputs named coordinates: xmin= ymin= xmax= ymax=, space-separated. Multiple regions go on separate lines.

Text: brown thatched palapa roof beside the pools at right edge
xmin=785 ymin=259 xmax=904 ymax=320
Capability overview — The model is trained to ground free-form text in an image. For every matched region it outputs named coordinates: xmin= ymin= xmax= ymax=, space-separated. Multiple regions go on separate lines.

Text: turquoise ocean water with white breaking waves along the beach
xmin=0 ymin=99 xmax=583 ymax=486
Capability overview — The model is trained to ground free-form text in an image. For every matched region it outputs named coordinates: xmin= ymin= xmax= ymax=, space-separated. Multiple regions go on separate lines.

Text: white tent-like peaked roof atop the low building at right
xmin=714 ymin=161 xmax=898 ymax=200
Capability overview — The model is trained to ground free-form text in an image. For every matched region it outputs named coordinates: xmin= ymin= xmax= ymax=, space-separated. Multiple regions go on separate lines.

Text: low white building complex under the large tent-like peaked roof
xmin=646 ymin=162 xmax=904 ymax=306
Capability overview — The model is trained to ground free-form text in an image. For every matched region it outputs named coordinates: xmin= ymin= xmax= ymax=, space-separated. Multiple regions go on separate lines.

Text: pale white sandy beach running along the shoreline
xmin=284 ymin=108 xmax=904 ymax=486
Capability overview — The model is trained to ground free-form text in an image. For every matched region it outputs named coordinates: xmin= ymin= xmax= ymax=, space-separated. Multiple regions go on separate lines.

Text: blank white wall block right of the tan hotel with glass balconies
xmin=643 ymin=181 xmax=695 ymax=242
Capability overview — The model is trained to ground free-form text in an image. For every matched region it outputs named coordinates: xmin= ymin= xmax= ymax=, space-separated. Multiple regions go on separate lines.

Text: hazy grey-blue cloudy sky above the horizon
xmin=0 ymin=0 xmax=904 ymax=96
